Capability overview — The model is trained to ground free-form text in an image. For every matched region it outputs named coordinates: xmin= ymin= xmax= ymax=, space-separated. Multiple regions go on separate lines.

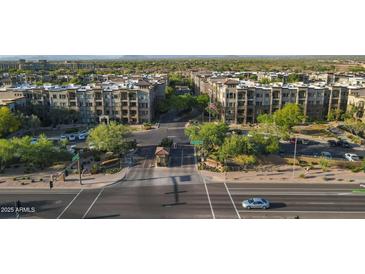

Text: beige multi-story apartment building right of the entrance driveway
xmin=193 ymin=74 xmax=349 ymax=124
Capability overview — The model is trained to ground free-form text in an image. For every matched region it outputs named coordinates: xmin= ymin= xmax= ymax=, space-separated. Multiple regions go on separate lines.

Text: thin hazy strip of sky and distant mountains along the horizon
xmin=0 ymin=55 xmax=365 ymax=61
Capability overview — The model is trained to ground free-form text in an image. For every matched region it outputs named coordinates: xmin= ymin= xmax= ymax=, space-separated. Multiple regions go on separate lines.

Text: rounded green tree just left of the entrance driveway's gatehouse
xmin=88 ymin=122 xmax=131 ymax=153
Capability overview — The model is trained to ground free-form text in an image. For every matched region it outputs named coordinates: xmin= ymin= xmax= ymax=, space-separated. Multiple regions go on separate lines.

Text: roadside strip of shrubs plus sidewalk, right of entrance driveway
xmin=200 ymin=155 xmax=365 ymax=185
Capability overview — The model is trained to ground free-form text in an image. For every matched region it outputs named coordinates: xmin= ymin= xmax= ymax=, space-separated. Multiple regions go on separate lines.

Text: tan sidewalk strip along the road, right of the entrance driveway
xmin=200 ymin=166 xmax=365 ymax=184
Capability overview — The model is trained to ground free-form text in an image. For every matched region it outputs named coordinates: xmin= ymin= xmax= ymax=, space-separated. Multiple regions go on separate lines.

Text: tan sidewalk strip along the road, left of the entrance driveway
xmin=0 ymin=168 xmax=128 ymax=190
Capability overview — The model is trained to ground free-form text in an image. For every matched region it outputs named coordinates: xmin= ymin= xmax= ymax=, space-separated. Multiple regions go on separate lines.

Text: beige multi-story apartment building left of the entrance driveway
xmin=49 ymin=80 xmax=164 ymax=124
